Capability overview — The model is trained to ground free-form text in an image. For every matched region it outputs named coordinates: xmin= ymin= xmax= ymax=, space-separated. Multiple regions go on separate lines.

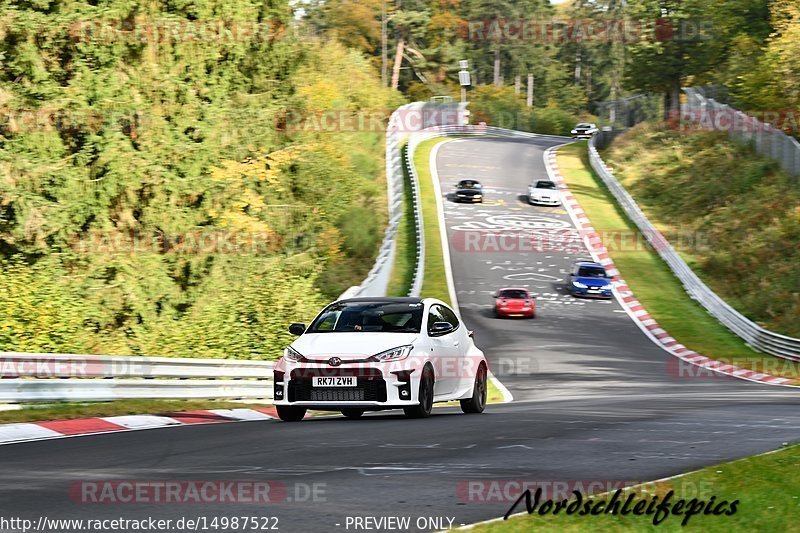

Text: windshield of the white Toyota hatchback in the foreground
xmin=308 ymin=302 xmax=423 ymax=333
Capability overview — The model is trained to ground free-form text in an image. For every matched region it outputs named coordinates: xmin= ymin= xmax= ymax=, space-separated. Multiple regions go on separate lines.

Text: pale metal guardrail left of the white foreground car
xmin=0 ymin=352 xmax=273 ymax=402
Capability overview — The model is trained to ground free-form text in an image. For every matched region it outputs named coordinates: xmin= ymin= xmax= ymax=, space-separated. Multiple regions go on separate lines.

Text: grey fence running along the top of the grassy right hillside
xmin=681 ymin=87 xmax=800 ymax=177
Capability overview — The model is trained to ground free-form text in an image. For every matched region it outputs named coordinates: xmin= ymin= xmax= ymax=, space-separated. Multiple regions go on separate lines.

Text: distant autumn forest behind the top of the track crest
xmin=304 ymin=0 xmax=800 ymax=132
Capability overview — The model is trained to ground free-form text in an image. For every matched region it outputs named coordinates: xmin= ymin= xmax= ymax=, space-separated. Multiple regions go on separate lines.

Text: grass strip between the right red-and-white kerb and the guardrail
xmin=557 ymin=142 xmax=800 ymax=379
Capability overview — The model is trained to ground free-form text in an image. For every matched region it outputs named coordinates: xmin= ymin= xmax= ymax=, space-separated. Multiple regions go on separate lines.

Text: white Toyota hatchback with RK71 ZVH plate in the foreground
xmin=274 ymin=297 xmax=488 ymax=421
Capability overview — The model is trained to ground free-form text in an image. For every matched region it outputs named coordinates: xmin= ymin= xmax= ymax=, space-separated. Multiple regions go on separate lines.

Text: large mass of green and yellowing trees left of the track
xmin=0 ymin=0 xmax=400 ymax=358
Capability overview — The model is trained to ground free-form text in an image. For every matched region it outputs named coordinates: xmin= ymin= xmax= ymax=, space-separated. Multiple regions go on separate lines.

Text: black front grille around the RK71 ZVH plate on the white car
xmin=288 ymin=368 xmax=386 ymax=402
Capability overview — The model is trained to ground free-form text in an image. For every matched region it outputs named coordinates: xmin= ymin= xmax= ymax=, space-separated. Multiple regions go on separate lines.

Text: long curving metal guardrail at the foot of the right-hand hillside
xmin=589 ymin=139 xmax=800 ymax=361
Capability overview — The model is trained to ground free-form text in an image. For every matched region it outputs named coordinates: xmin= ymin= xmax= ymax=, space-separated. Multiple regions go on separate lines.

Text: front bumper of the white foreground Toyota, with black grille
xmin=273 ymin=362 xmax=420 ymax=410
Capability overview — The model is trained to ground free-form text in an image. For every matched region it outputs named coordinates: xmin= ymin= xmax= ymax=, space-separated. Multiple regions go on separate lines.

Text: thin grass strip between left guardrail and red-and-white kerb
xmin=0 ymin=400 xmax=267 ymax=424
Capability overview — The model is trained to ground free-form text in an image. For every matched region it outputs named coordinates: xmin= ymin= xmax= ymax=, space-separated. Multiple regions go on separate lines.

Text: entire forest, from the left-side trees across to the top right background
xmin=0 ymin=0 xmax=800 ymax=358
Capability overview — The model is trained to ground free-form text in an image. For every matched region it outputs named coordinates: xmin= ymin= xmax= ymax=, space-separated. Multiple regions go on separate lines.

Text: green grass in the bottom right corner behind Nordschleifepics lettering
xmin=473 ymin=446 xmax=800 ymax=533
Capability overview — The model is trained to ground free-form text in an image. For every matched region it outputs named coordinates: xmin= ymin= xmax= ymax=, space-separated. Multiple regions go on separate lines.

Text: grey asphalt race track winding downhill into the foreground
xmin=0 ymin=138 xmax=800 ymax=531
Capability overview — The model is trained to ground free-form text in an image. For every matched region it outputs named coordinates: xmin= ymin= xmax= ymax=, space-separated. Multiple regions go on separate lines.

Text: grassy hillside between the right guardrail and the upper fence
xmin=603 ymin=125 xmax=800 ymax=337
